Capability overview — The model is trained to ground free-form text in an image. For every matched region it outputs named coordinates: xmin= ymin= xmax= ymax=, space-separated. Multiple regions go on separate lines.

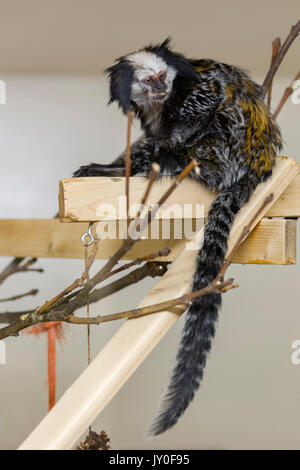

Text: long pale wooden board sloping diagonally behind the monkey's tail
xmin=20 ymin=156 xmax=298 ymax=450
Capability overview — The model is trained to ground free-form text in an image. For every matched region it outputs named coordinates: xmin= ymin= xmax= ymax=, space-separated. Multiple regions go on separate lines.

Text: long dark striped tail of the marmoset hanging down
xmin=149 ymin=176 xmax=258 ymax=436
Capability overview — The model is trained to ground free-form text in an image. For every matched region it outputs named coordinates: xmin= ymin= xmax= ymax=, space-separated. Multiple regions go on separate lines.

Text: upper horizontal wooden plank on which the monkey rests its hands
xmin=59 ymin=157 xmax=300 ymax=222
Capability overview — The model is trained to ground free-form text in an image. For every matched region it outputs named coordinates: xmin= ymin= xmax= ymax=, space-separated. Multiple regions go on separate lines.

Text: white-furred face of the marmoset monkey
xmin=127 ymin=51 xmax=176 ymax=107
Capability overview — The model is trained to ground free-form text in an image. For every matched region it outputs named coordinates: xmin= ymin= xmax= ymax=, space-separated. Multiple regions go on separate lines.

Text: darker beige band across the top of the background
xmin=0 ymin=0 xmax=300 ymax=75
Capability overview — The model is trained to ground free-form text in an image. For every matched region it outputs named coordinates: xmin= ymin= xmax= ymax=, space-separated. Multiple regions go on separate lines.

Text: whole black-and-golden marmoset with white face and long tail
xmin=74 ymin=38 xmax=282 ymax=435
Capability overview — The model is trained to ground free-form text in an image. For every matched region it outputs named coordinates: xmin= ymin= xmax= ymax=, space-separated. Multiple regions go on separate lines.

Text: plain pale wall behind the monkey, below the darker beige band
xmin=0 ymin=2 xmax=300 ymax=449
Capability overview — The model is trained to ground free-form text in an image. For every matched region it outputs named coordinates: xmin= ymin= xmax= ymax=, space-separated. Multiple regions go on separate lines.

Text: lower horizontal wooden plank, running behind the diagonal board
xmin=0 ymin=218 xmax=297 ymax=264
